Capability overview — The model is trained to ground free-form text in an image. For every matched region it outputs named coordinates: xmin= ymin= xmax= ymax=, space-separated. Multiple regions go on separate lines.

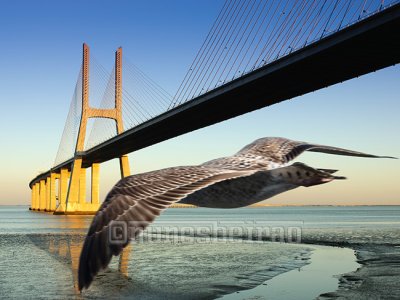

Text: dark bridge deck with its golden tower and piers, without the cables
xmin=29 ymin=3 xmax=400 ymax=213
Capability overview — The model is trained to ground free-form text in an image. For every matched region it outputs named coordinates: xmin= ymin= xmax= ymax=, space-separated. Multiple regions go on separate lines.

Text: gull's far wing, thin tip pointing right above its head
xmin=236 ymin=137 xmax=396 ymax=164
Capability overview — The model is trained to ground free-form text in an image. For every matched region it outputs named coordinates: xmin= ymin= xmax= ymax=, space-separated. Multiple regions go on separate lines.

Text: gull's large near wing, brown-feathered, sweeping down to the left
xmin=78 ymin=166 xmax=252 ymax=290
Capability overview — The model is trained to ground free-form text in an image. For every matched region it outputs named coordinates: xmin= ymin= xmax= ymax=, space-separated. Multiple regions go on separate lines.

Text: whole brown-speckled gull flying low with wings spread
xmin=78 ymin=137 xmax=394 ymax=290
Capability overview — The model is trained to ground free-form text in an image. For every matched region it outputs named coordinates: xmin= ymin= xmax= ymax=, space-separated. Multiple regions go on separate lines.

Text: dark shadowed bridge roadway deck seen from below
xmin=30 ymin=4 xmax=400 ymax=188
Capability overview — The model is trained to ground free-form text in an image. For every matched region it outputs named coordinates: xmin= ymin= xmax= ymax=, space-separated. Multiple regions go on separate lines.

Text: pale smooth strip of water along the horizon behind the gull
xmin=0 ymin=206 xmax=400 ymax=234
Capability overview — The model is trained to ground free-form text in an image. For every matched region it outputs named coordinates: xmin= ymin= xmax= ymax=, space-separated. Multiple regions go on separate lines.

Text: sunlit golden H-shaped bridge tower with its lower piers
xmin=53 ymin=44 xmax=130 ymax=214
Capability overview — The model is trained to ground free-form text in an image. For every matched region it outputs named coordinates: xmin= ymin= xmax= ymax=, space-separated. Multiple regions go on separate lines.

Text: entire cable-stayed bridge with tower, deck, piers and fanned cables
xmin=29 ymin=0 xmax=400 ymax=214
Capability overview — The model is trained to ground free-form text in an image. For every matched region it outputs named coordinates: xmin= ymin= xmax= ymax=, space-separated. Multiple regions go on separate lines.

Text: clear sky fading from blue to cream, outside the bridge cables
xmin=0 ymin=0 xmax=400 ymax=205
